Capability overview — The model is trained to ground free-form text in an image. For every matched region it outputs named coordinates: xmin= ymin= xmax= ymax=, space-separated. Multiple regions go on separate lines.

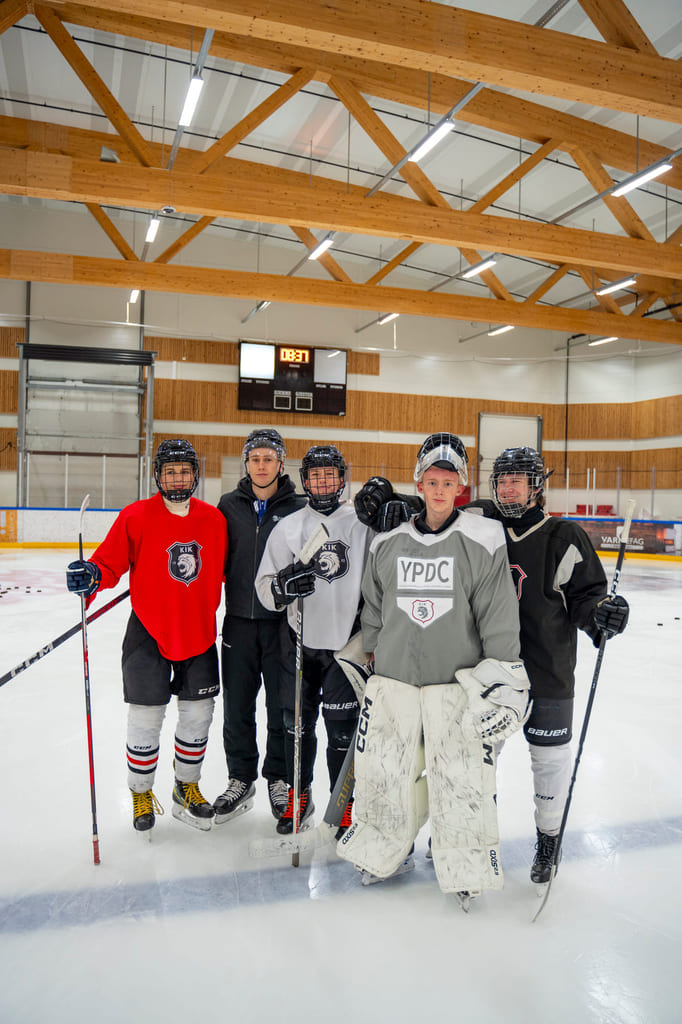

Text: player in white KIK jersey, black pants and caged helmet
xmin=255 ymin=444 xmax=373 ymax=835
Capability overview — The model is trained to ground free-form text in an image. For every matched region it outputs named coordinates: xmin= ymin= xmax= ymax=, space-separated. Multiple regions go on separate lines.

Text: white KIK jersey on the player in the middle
xmin=255 ymin=504 xmax=374 ymax=650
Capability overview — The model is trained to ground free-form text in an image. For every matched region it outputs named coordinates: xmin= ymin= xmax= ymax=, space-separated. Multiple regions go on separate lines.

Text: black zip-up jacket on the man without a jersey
xmin=218 ymin=474 xmax=305 ymax=618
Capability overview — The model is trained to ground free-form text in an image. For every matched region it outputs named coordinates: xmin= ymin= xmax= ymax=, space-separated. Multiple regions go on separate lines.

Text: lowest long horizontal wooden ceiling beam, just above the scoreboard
xmin=0 ymin=249 xmax=682 ymax=345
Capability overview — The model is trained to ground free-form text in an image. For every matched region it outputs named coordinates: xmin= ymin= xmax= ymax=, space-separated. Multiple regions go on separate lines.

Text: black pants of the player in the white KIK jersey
xmin=281 ymin=623 xmax=359 ymax=791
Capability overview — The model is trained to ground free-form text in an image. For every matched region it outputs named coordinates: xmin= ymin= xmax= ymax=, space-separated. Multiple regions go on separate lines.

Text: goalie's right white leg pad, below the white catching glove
xmin=420 ymin=683 xmax=504 ymax=893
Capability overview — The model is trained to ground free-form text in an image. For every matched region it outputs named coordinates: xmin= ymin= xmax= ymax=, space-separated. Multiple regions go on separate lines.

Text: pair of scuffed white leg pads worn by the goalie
xmin=337 ymin=675 xmax=503 ymax=893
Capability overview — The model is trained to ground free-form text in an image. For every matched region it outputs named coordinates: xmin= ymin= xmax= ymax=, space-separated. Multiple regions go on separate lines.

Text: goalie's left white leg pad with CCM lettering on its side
xmin=337 ymin=675 xmax=426 ymax=879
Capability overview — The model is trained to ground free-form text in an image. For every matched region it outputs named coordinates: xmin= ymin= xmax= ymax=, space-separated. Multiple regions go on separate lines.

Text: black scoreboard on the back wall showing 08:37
xmin=238 ymin=341 xmax=347 ymax=416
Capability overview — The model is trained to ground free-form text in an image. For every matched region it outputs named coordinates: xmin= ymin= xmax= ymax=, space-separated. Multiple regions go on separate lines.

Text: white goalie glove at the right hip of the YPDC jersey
xmin=455 ymin=657 xmax=530 ymax=742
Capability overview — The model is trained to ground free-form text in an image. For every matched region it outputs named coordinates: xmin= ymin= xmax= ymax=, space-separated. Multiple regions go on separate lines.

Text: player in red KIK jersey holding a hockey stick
xmin=67 ymin=439 xmax=227 ymax=831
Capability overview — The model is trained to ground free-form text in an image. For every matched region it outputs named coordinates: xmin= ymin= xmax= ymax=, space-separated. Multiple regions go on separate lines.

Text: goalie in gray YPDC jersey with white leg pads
xmin=338 ymin=433 xmax=529 ymax=909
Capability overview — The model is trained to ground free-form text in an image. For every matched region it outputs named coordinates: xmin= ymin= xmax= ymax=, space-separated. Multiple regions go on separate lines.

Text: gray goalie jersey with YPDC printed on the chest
xmin=364 ymin=512 xmax=519 ymax=686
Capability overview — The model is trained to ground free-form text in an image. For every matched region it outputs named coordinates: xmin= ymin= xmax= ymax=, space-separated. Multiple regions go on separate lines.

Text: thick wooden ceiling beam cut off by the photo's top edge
xmin=55 ymin=0 xmax=682 ymax=122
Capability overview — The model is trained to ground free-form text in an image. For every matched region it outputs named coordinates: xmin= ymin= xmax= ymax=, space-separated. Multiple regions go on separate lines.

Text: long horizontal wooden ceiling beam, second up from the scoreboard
xmin=5 ymin=150 xmax=682 ymax=279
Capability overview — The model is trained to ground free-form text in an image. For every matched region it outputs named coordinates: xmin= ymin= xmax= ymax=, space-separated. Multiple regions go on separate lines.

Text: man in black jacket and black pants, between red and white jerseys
xmin=214 ymin=429 xmax=305 ymax=824
